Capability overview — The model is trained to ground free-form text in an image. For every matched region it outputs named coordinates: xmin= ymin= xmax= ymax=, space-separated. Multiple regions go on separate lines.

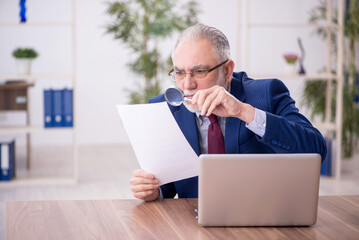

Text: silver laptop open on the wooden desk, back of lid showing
xmin=198 ymin=154 xmax=321 ymax=226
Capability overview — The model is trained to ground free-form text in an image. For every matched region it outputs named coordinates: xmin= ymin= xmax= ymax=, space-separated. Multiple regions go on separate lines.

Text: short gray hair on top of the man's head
xmin=172 ymin=23 xmax=231 ymax=62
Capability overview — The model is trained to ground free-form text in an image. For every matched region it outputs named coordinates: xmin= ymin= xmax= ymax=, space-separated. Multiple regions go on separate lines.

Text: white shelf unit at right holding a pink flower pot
xmin=236 ymin=0 xmax=345 ymax=180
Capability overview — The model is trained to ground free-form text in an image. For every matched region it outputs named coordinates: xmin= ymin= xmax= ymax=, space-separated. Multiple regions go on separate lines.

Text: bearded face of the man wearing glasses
xmin=173 ymin=39 xmax=226 ymax=111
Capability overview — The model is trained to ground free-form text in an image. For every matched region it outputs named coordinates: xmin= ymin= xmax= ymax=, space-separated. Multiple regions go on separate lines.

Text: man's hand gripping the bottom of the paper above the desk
xmin=130 ymin=169 xmax=160 ymax=201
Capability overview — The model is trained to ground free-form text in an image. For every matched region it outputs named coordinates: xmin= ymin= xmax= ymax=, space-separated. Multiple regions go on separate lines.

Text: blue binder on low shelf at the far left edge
xmin=0 ymin=139 xmax=15 ymax=181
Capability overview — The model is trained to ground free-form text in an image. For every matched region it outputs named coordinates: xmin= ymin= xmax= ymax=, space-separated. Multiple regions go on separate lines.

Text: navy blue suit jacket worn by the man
xmin=149 ymin=72 xmax=326 ymax=198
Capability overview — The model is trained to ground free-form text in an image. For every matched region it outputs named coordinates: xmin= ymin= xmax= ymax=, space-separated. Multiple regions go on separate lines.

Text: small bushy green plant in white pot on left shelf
xmin=12 ymin=48 xmax=39 ymax=75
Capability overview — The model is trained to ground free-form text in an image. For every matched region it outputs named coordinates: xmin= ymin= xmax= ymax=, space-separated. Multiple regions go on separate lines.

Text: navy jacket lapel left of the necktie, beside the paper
xmin=173 ymin=105 xmax=201 ymax=156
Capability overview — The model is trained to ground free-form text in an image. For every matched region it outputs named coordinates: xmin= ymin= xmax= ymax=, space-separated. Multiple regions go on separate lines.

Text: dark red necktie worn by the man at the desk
xmin=208 ymin=114 xmax=226 ymax=154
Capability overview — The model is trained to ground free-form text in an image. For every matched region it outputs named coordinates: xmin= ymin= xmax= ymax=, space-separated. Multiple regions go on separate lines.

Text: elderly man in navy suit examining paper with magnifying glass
xmin=130 ymin=24 xmax=326 ymax=201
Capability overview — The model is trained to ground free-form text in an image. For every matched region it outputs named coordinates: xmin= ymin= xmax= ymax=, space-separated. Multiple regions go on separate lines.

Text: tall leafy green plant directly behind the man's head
xmin=107 ymin=0 xmax=198 ymax=104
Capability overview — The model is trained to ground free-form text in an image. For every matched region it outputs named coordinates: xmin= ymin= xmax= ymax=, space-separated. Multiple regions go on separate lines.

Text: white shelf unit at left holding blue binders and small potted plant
xmin=0 ymin=0 xmax=78 ymax=187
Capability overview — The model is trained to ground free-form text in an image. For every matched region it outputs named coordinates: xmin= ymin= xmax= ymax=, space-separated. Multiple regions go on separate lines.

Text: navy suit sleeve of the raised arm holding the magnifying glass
xmin=258 ymin=79 xmax=327 ymax=161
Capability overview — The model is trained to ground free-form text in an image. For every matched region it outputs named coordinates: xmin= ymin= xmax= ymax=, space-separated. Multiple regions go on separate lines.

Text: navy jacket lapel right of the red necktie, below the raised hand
xmin=224 ymin=76 xmax=245 ymax=153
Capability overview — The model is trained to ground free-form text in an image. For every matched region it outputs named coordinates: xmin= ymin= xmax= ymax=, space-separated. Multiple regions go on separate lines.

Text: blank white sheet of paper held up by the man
xmin=117 ymin=102 xmax=199 ymax=185
